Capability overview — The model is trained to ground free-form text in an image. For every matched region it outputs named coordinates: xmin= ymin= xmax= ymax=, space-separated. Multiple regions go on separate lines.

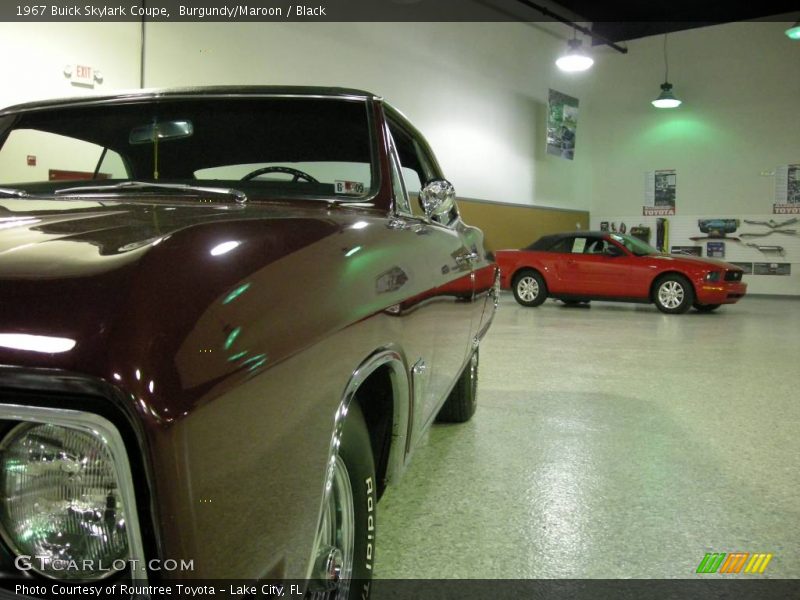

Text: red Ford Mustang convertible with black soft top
xmin=496 ymin=232 xmax=747 ymax=314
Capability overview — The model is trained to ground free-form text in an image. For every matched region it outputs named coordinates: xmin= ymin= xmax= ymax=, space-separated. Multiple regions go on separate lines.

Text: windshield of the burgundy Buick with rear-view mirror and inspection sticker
xmin=0 ymin=96 xmax=376 ymax=201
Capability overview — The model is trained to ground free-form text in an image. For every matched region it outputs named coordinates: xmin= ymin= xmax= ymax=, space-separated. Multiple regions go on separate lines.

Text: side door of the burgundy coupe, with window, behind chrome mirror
xmin=387 ymin=114 xmax=476 ymax=439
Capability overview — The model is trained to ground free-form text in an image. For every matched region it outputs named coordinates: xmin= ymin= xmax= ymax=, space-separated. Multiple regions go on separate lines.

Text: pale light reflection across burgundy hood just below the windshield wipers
xmin=0 ymin=199 xmax=338 ymax=279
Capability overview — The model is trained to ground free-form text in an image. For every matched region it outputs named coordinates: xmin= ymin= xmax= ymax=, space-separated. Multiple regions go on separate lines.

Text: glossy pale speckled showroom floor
xmin=376 ymin=293 xmax=800 ymax=579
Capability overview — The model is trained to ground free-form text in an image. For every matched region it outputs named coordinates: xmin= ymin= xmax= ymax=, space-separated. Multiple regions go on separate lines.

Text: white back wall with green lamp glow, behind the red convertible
xmin=581 ymin=23 xmax=800 ymax=294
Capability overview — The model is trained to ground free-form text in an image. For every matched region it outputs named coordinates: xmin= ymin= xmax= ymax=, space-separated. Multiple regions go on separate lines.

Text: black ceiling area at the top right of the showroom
xmin=522 ymin=0 xmax=798 ymax=44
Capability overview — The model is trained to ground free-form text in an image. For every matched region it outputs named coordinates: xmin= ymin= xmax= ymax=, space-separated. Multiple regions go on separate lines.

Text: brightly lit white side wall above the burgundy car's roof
xmin=145 ymin=23 xmax=588 ymax=209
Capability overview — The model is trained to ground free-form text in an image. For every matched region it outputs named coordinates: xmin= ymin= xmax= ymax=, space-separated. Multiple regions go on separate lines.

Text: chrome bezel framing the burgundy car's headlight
xmin=0 ymin=404 xmax=147 ymax=583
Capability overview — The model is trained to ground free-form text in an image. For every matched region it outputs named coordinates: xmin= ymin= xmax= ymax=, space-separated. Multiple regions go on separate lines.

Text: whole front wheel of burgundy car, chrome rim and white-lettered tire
xmin=308 ymin=402 xmax=378 ymax=600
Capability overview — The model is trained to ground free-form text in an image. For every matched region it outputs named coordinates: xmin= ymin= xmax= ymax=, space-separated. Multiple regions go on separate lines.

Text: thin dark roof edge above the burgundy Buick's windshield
xmin=0 ymin=85 xmax=381 ymax=116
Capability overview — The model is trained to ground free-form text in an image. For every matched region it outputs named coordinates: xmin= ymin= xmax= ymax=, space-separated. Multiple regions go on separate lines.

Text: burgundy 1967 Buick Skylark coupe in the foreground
xmin=0 ymin=87 xmax=497 ymax=597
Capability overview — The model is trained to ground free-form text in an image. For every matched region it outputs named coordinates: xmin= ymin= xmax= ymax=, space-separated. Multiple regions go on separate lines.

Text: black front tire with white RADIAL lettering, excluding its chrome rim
xmin=306 ymin=401 xmax=378 ymax=600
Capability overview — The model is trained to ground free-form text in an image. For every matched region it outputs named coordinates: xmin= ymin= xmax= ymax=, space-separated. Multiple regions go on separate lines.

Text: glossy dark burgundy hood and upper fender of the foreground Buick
xmin=0 ymin=199 xmax=346 ymax=386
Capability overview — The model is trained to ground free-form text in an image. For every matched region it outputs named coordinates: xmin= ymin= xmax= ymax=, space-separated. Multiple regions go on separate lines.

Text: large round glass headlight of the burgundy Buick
xmin=0 ymin=423 xmax=129 ymax=580
